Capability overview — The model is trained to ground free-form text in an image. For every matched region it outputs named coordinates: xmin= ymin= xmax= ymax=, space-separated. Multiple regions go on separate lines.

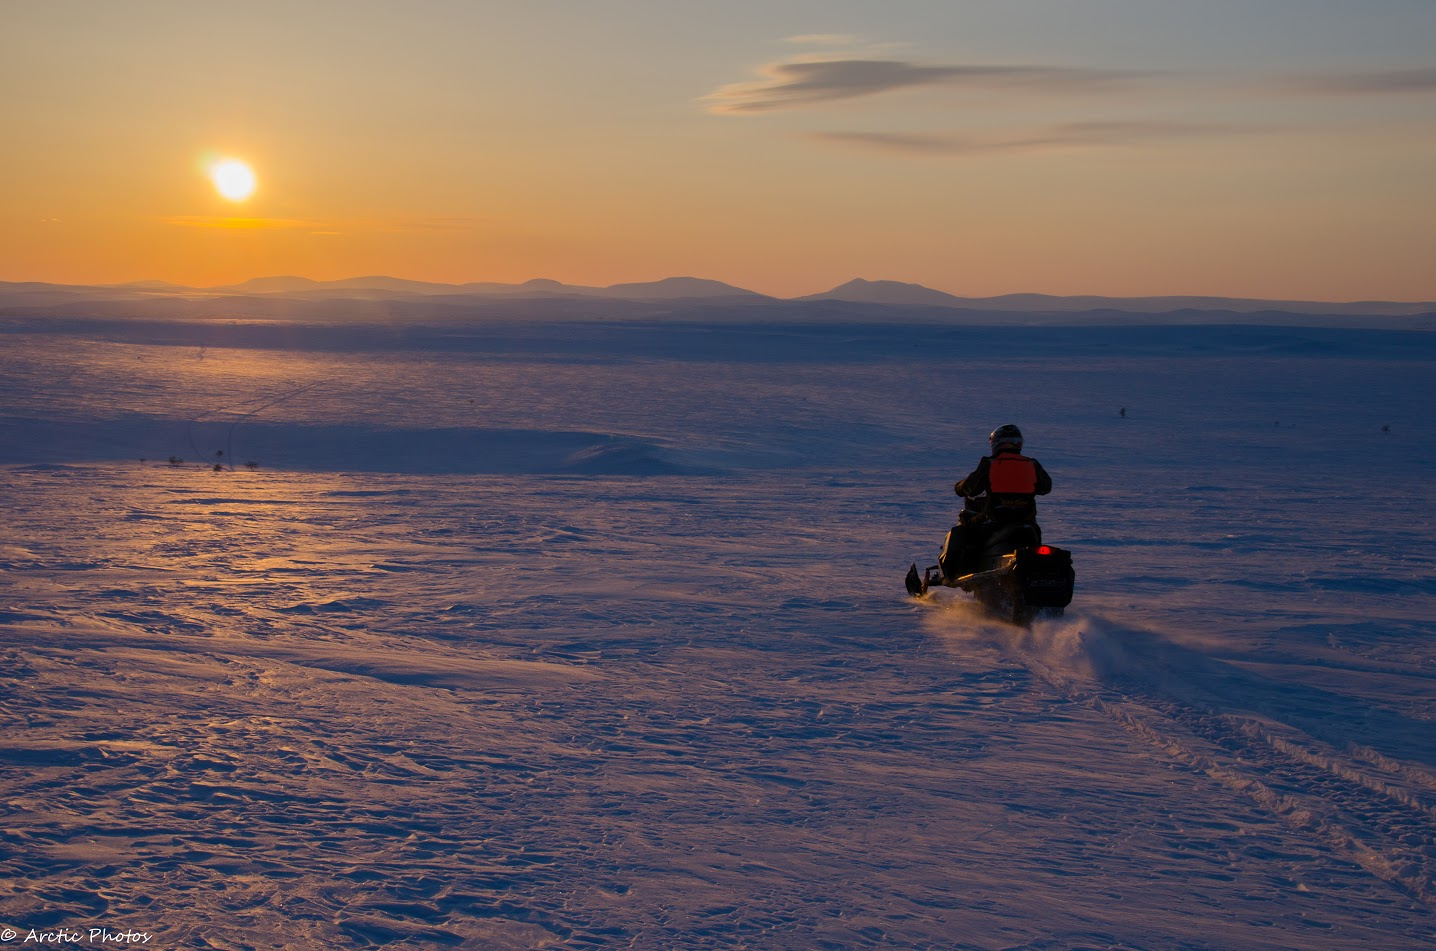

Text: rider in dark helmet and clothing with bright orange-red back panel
xmin=938 ymin=424 xmax=1053 ymax=579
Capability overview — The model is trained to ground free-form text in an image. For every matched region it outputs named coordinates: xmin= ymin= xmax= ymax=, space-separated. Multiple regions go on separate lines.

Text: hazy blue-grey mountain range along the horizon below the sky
xmin=0 ymin=276 xmax=1436 ymax=322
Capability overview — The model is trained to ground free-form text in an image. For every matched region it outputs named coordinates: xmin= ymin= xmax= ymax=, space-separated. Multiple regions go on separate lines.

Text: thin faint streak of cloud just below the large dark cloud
xmin=807 ymin=119 xmax=1265 ymax=157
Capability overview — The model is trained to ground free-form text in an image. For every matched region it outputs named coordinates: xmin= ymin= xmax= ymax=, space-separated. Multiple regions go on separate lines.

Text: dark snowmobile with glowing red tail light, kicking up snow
xmin=906 ymin=523 xmax=1077 ymax=628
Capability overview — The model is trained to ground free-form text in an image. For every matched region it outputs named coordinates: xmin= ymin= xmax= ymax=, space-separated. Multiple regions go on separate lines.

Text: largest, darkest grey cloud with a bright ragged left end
xmin=704 ymin=59 xmax=1150 ymax=115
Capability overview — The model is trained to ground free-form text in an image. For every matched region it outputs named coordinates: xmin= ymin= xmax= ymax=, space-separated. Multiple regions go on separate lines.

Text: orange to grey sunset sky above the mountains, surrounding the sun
xmin=0 ymin=0 xmax=1436 ymax=300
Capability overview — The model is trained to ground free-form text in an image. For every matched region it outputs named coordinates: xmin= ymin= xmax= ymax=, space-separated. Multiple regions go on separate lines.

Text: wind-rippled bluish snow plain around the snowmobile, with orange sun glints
xmin=0 ymin=320 xmax=1436 ymax=950
